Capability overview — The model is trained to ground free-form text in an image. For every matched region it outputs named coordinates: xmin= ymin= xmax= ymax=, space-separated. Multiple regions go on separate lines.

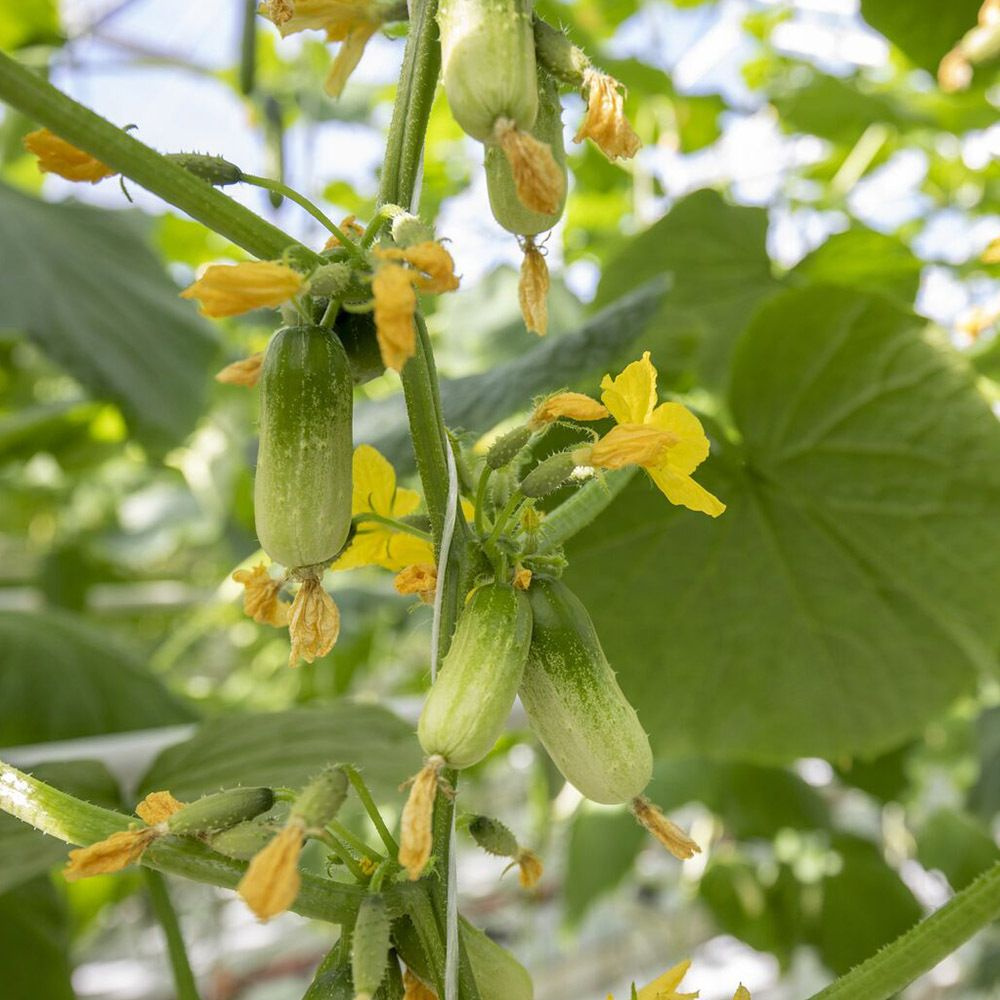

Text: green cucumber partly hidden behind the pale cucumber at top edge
xmin=486 ymin=69 xmax=566 ymax=236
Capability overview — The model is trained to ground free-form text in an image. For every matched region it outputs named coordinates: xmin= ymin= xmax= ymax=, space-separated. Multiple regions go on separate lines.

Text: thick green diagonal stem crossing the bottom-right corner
xmin=809 ymin=862 xmax=1000 ymax=1000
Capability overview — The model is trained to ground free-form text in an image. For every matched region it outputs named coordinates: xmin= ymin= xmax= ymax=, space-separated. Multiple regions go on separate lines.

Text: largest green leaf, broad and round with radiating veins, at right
xmin=567 ymin=287 xmax=1000 ymax=761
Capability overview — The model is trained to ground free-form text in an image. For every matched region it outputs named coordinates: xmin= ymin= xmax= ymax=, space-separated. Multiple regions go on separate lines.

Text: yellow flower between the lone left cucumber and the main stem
xmin=331 ymin=444 xmax=434 ymax=571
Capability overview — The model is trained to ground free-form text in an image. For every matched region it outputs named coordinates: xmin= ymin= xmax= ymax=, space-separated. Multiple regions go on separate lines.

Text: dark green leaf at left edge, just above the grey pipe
xmin=0 ymin=611 xmax=192 ymax=746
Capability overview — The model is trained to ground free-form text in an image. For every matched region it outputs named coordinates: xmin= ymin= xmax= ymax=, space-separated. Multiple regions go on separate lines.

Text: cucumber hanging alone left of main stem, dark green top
xmin=254 ymin=326 xmax=353 ymax=569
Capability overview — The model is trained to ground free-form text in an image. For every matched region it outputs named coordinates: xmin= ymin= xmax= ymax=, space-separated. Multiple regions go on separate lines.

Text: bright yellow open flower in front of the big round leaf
xmin=580 ymin=351 xmax=726 ymax=517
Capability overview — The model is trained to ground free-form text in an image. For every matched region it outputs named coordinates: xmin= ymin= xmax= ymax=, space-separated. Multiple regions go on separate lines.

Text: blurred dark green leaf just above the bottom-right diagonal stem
xmin=816 ymin=834 xmax=923 ymax=975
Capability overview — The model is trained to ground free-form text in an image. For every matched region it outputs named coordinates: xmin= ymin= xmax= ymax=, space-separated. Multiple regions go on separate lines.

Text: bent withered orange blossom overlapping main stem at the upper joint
xmin=372 ymin=240 xmax=458 ymax=372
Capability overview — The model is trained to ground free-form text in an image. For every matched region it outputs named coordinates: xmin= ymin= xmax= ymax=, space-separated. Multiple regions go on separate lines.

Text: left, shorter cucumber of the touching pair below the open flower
xmin=417 ymin=583 xmax=531 ymax=768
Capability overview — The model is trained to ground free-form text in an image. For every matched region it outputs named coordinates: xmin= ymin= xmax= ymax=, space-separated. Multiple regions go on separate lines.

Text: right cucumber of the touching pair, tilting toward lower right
xmin=519 ymin=578 xmax=653 ymax=805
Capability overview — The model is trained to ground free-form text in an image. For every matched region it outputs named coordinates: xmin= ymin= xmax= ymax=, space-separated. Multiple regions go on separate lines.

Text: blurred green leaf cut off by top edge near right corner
xmin=861 ymin=0 xmax=982 ymax=73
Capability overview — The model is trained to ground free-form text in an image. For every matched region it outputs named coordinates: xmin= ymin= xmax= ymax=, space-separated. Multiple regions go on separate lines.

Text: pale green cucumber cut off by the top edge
xmin=438 ymin=0 xmax=538 ymax=143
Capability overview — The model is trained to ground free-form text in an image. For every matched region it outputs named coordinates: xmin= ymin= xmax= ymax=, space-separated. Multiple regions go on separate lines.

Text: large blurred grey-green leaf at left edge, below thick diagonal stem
xmin=0 ymin=185 xmax=216 ymax=448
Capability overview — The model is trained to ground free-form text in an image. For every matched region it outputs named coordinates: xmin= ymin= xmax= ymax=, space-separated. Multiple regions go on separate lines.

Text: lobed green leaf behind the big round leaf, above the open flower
xmin=594 ymin=190 xmax=780 ymax=385
